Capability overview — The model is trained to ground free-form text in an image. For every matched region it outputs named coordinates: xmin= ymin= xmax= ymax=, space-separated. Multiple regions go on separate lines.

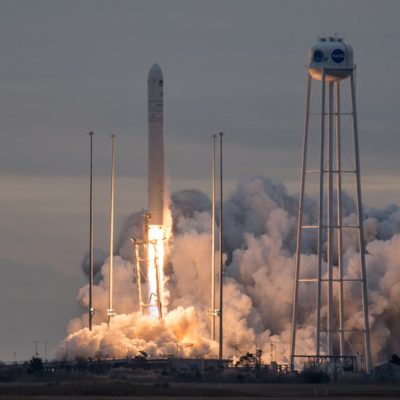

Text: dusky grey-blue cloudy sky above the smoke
xmin=0 ymin=0 xmax=400 ymax=361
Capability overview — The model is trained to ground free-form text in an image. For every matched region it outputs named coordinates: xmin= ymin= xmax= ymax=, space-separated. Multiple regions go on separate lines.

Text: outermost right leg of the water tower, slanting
xmin=350 ymin=69 xmax=372 ymax=371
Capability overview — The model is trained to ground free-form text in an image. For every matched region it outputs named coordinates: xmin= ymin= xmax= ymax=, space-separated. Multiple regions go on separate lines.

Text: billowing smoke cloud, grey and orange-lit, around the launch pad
xmin=59 ymin=177 xmax=400 ymax=362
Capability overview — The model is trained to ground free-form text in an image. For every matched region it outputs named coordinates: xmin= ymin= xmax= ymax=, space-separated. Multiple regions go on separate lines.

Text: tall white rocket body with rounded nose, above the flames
xmin=147 ymin=64 xmax=165 ymax=225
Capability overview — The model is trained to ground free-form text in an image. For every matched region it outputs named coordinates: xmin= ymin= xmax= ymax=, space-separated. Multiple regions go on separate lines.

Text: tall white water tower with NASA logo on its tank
xmin=291 ymin=36 xmax=371 ymax=371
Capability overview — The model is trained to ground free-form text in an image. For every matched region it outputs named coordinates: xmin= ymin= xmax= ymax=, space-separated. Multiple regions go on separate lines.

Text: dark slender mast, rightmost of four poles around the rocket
xmin=219 ymin=132 xmax=224 ymax=360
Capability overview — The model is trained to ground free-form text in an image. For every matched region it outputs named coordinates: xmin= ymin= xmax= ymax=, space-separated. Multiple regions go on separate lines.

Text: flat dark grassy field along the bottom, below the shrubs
xmin=0 ymin=382 xmax=400 ymax=400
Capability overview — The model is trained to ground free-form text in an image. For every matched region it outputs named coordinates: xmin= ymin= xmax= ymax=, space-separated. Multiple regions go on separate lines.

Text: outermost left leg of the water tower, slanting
xmin=290 ymin=74 xmax=312 ymax=368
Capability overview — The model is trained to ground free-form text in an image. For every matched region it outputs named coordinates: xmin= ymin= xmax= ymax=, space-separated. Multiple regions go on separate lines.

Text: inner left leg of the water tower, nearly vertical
xmin=316 ymin=69 xmax=326 ymax=357
